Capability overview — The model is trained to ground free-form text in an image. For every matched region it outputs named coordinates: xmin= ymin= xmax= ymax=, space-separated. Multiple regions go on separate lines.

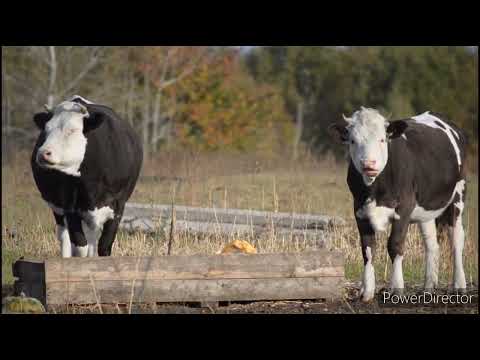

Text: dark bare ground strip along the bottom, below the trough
xmin=2 ymin=283 xmax=479 ymax=314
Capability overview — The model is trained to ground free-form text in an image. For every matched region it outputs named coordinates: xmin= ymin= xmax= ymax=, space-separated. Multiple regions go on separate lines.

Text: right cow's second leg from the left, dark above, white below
xmin=387 ymin=215 xmax=409 ymax=294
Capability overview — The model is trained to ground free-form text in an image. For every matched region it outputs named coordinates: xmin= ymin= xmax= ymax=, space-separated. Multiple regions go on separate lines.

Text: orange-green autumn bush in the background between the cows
xmin=172 ymin=52 xmax=293 ymax=151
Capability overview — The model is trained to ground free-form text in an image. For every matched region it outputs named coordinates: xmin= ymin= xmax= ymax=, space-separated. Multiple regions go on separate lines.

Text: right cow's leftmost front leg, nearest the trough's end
xmin=355 ymin=217 xmax=376 ymax=302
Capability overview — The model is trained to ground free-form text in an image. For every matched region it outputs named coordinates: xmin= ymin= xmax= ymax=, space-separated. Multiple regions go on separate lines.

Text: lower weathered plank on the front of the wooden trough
xmin=47 ymin=277 xmax=343 ymax=305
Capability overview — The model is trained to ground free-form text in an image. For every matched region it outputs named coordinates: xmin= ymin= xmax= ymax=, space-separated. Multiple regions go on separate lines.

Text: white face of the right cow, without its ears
xmin=345 ymin=107 xmax=388 ymax=186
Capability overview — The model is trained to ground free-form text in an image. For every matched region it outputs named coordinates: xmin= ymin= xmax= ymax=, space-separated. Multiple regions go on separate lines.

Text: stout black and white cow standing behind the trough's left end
xmin=31 ymin=96 xmax=143 ymax=257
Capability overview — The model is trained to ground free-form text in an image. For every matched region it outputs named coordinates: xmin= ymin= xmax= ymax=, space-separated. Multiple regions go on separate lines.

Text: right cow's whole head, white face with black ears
xmin=334 ymin=107 xmax=406 ymax=186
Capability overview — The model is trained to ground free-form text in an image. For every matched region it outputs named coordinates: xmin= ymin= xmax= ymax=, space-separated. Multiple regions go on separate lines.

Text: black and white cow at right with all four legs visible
xmin=330 ymin=107 xmax=466 ymax=301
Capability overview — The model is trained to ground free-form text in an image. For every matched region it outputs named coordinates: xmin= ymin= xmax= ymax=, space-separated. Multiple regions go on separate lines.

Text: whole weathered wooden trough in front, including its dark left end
xmin=15 ymin=250 xmax=344 ymax=305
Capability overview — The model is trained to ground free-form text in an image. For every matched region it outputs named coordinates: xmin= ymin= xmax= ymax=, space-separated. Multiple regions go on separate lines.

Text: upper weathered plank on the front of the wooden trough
xmin=45 ymin=250 xmax=344 ymax=284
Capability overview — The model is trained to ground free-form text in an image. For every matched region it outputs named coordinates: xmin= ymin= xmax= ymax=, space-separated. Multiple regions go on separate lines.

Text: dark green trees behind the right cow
xmin=246 ymin=46 xmax=478 ymax=158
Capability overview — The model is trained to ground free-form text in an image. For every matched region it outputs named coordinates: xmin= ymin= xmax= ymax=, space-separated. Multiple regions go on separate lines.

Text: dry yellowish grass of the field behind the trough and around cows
xmin=2 ymin=149 xmax=478 ymax=285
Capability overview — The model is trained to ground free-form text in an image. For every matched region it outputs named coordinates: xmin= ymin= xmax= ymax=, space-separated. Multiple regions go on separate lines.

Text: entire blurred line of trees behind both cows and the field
xmin=2 ymin=46 xmax=478 ymax=159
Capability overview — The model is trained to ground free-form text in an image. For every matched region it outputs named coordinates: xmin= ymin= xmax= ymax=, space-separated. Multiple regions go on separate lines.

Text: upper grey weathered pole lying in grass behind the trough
xmin=124 ymin=203 xmax=345 ymax=230
